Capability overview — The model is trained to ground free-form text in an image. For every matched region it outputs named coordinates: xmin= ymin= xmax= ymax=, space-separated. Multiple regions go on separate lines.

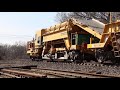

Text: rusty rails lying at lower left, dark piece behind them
xmin=0 ymin=65 xmax=47 ymax=78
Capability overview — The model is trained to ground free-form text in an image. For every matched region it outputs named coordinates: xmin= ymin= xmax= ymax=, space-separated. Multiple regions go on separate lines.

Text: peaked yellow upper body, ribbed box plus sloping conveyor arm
xmin=43 ymin=19 xmax=102 ymax=50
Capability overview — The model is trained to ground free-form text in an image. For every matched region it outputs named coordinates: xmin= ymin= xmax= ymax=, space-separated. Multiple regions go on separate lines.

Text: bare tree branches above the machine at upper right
xmin=55 ymin=12 xmax=120 ymax=24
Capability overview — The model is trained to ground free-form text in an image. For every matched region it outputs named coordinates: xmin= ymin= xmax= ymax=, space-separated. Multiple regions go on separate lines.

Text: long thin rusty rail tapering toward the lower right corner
xmin=35 ymin=69 xmax=120 ymax=78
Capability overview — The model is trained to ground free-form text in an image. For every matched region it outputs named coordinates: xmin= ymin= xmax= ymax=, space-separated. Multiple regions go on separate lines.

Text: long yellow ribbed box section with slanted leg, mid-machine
xmin=43 ymin=21 xmax=70 ymax=49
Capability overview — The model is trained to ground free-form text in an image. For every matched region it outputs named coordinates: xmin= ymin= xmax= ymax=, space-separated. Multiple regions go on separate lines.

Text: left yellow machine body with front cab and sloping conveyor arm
xmin=27 ymin=19 xmax=102 ymax=59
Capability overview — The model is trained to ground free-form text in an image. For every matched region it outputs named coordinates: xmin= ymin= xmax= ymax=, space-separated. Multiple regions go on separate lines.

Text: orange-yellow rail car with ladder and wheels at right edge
xmin=87 ymin=21 xmax=120 ymax=62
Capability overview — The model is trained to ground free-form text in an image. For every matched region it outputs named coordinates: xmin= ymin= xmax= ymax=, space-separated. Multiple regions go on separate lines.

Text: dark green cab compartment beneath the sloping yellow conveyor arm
xmin=71 ymin=32 xmax=99 ymax=49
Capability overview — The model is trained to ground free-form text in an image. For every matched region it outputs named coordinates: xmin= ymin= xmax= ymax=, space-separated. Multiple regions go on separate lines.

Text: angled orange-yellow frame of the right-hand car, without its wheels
xmin=87 ymin=22 xmax=120 ymax=48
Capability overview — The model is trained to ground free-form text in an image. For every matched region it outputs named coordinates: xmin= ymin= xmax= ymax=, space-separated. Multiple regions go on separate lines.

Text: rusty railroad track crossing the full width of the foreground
xmin=0 ymin=68 xmax=120 ymax=78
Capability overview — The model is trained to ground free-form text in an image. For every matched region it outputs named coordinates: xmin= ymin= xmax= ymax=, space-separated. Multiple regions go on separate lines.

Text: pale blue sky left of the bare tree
xmin=0 ymin=12 xmax=57 ymax=44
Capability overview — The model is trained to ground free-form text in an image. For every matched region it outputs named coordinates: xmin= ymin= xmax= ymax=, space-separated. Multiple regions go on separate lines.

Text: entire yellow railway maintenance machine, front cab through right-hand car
xmin=28 ymin=18 xmax=120 ymax=62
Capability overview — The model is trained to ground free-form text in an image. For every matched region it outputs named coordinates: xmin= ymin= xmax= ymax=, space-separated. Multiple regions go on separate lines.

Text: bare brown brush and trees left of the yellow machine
xmin=0 ymin=42 xmax=28 ymax=60
